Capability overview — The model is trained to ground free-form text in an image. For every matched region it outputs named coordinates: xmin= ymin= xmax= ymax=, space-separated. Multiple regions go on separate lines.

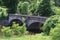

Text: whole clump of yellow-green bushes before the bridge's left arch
xmin=1 ymin=22 xmax=27 ymax=37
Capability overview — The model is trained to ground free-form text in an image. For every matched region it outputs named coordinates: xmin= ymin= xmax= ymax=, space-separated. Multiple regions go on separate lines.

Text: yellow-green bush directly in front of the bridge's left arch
xmin=12 ymin=23 xmax=26 ymax=36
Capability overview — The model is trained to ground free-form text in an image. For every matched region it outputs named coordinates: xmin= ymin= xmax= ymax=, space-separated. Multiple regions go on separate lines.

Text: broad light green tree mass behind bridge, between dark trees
xmin=17 ymin=0 xmax=42 ymax=15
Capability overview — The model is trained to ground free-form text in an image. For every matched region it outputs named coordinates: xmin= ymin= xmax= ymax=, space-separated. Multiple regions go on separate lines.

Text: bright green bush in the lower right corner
xmin=50 ymin=24 xmax=60 ymax=40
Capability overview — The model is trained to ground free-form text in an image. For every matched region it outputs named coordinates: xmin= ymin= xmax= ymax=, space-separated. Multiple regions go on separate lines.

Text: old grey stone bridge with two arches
xmin=9 ymin=14 xmax=47 ymax=30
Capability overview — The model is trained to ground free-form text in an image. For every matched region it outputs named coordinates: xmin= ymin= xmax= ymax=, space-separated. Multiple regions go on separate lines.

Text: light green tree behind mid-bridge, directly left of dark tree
xmin=29 ymin=0 xmax=42 ymax=16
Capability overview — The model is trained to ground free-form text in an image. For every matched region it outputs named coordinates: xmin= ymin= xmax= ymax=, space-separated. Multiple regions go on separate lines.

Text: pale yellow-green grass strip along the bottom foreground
xmin=0 ymin=34 xmax=51 ymax=40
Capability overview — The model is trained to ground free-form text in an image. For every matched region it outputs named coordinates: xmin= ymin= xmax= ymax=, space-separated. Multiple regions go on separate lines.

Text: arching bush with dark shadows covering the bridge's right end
xmin=43 ymin=15 xmax=60 ymax=35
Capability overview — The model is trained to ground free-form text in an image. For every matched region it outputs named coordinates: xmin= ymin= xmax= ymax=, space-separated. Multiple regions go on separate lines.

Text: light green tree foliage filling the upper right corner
xmin=50 ymin=0 xmax=60 ymax=15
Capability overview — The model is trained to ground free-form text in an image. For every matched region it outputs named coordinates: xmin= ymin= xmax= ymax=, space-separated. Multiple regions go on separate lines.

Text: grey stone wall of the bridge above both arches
xmin=9 ymin=14 xmax=47 ymax=23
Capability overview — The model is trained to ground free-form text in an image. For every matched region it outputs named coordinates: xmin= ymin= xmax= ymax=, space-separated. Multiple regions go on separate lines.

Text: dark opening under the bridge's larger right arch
xmin=28 ymin=22 xmax=43 ymax=33
